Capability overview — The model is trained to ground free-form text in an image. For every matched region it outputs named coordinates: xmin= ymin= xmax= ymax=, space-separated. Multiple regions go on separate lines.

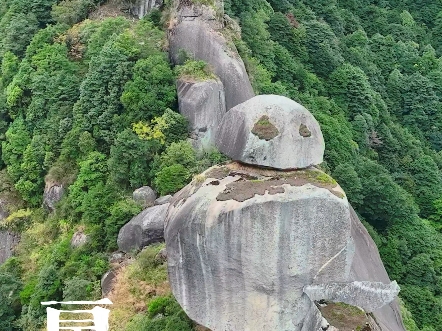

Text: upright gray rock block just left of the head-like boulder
xmin=177 ymin=79 xmax=226 ymax=151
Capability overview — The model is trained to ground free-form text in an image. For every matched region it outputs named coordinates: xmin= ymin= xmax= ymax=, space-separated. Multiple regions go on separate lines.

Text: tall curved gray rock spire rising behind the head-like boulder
xmin=169 ymin=5 xmax=255 ymax=110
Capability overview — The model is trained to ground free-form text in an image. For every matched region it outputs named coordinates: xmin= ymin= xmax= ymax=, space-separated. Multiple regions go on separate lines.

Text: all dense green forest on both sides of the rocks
xmin=0 ymin=0 xmax=442 ymax=331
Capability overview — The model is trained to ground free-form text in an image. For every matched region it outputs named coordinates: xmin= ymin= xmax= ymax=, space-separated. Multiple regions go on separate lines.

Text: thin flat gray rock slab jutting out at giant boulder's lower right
xmin=304 ymin=282 xmax=399 ymax=313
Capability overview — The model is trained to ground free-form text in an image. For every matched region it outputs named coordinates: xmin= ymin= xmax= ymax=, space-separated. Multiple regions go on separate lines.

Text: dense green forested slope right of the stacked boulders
xmin=225 ymin=0 xmax=442 ymax=330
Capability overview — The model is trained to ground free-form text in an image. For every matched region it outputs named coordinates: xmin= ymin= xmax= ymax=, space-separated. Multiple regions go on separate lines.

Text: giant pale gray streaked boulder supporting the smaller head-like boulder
xmin=165 ymin=163 xmax=397 ymax=331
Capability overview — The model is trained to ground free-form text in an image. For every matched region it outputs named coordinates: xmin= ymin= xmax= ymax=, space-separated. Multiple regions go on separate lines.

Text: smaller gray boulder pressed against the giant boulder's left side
xmin=117 ymin=203 xmax=169 ymax=253
